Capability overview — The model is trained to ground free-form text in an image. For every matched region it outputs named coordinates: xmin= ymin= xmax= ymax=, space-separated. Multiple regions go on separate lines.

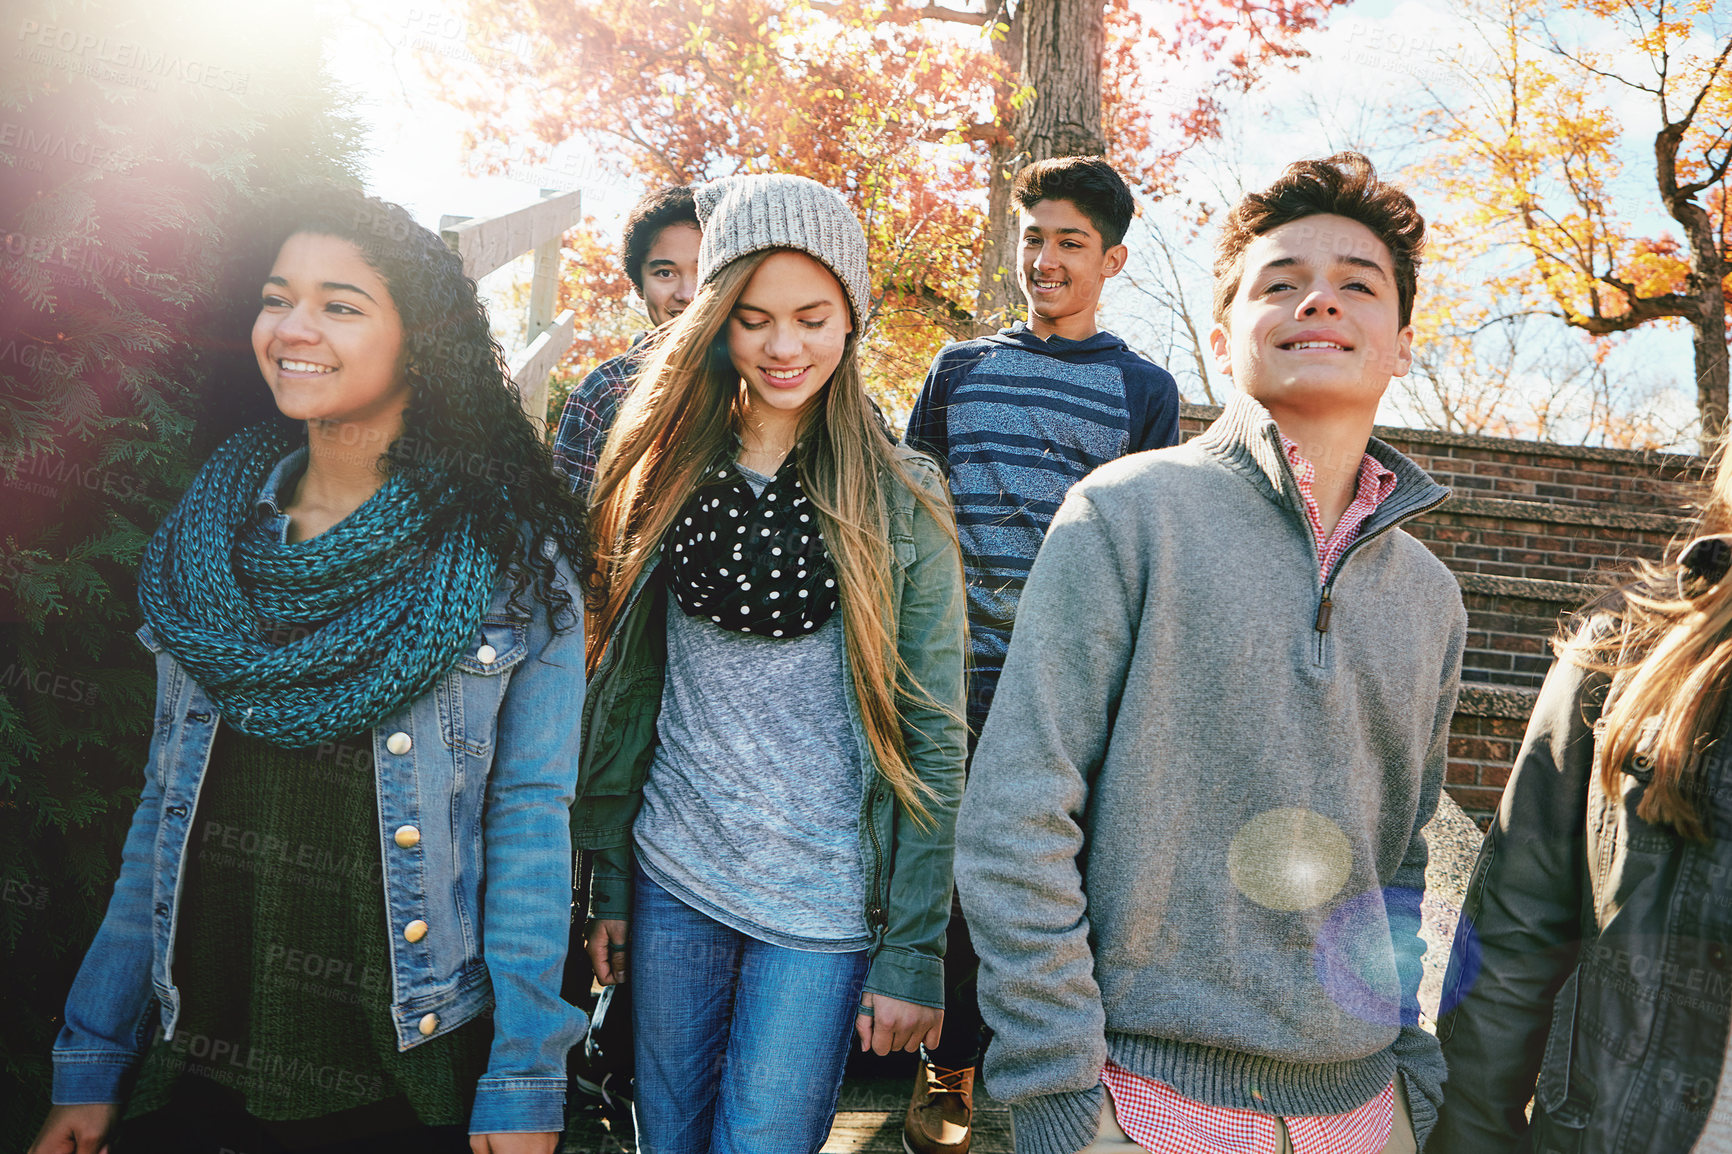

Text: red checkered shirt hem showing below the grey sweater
xmin=1100 ymin=1060 xmax=1396 ymax=1154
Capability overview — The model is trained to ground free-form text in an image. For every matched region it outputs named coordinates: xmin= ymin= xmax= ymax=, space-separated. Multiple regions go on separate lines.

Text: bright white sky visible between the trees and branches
xmin=327 ymin=0 xmax=1694 ymax=443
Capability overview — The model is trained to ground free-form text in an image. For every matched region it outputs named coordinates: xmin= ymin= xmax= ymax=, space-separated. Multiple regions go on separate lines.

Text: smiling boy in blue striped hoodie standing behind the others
xmin=904 ymin=156 xmax=1179 ymax=1154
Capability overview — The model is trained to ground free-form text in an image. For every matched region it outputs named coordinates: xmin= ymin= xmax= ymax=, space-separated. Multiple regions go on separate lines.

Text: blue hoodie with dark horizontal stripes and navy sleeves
xmin=908 ymin=322 xmax=1179 ymax=733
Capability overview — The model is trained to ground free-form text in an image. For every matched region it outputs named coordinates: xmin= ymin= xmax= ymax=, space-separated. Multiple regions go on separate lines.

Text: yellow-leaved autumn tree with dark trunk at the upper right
xmin=1429 ymin=0 xmax=1732 ymax=444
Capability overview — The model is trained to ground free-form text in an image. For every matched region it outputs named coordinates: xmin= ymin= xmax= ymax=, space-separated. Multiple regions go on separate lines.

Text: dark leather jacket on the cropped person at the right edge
xmin=1425 ymin=637 xmax=1732 ymax=1154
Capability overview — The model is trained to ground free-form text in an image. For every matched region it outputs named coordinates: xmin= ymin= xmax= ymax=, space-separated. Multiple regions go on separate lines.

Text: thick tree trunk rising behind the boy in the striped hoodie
xmin=975 ymin=0 xmax=1107 ymax=333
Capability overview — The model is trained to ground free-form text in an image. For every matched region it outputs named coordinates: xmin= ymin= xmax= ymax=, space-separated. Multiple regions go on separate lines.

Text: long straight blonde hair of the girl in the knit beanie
xmin=585 ymin=250 xmax=961 ymax=823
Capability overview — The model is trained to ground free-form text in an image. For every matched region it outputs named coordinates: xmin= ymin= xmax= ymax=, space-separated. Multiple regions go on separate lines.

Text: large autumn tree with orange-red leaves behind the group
xmin=423 ymin=0 xmax=1328 ymax=415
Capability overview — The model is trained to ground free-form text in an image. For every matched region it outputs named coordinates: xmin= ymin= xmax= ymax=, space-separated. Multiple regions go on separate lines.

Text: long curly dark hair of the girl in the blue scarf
xmin=192 ymin=185 xmax=585 ymax=629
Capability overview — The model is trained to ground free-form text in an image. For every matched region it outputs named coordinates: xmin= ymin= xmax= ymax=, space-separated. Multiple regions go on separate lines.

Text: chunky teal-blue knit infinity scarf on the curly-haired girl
xmin=139 ymin=425 xmax=499 ymax=749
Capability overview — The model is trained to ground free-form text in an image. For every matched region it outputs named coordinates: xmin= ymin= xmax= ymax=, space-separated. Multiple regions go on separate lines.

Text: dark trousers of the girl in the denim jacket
xmin=113 ymin=1074 xmax=469 ymax=1154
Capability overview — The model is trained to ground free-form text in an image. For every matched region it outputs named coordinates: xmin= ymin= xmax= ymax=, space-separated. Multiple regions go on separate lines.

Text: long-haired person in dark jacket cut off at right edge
xmin=1427 ymin=436 xmax=1732 ymax=1154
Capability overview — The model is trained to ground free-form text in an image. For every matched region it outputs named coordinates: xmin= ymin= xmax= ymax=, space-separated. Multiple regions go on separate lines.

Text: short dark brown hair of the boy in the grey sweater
xmin=1214 ymin=152 xmax=1425 ymax=327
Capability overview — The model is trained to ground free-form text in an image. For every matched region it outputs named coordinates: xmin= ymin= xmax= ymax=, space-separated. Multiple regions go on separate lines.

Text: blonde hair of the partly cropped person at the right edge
xmin=1555 ymin=444 xmax=1732 ymax=840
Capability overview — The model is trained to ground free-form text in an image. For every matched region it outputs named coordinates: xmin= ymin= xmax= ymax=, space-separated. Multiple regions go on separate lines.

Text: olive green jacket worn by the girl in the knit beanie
xmin=573 ymin=445 xmax=968 ymax=1007
